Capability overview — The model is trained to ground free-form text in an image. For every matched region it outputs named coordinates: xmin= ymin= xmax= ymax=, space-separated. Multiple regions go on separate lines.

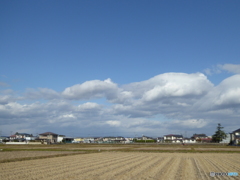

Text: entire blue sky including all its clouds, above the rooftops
xmin=0 ymin=0 xmax=240 ymax=136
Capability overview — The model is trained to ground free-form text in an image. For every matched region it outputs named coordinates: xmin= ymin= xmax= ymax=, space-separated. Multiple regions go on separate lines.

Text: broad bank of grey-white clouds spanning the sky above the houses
xmin=0 ymin=73 xmax=240 ymax=136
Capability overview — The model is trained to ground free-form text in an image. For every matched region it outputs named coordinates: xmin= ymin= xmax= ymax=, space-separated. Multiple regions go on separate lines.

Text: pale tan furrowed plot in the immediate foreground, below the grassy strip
xmin=0 ymin=152 xmax=240 ymax=180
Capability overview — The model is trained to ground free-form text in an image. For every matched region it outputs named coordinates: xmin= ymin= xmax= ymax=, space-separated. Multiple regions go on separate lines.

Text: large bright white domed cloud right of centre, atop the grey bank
xmin=123 ymin=73 xmax=213 ymax=101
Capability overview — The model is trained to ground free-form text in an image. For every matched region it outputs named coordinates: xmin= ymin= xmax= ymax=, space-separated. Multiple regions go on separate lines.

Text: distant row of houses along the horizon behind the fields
xmin=0 ymin=129 xmax=240 ymax=144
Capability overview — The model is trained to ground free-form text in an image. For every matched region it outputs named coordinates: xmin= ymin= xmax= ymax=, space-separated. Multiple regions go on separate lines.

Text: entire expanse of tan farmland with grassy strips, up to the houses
xmin=0 ymin=144 xmax=240 ymax=180
